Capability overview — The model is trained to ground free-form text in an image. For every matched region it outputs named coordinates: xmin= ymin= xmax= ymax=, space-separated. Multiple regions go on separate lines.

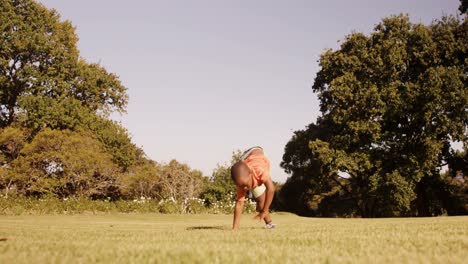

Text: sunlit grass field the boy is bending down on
xmin=0 ymin=214 xmax=468 ymax=264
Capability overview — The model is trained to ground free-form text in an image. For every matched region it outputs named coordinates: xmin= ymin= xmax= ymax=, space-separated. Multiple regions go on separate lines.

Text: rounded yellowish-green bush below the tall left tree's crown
xmin=6 ymin=129 xmax=118 ymax=199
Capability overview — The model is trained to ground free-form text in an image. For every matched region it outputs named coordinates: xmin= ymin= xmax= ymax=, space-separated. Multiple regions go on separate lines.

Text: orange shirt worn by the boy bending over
xmin=237 ymin=152 xmax=271 ymax=201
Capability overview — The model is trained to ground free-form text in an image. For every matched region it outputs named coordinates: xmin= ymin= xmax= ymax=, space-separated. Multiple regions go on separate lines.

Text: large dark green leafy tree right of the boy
xmin=283 ymin=15 xmax=468 ymax=217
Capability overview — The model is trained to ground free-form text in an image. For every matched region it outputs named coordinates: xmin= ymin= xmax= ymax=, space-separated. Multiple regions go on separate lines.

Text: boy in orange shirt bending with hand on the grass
xmin=231 ymin=147 xmax=275 ymax=229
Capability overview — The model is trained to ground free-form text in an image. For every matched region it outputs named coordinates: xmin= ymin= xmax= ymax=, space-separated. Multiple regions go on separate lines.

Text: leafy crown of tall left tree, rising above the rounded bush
xmin=0 ymin=0 xmax=127 ymax=129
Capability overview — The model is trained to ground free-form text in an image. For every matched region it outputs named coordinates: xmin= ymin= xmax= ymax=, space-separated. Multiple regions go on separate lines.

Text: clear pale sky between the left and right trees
xmin=39 ymin=0 xmax=459 ymax=182
